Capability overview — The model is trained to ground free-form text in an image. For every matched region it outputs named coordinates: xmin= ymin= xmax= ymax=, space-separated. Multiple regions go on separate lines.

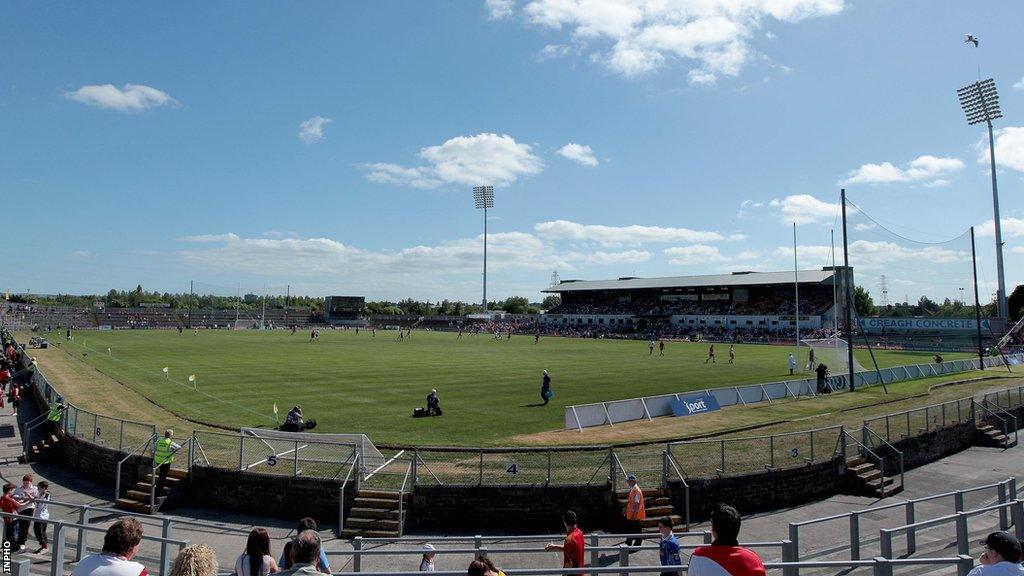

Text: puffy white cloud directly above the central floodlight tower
xmin=360 ymin=133 xmax=544 ymax=188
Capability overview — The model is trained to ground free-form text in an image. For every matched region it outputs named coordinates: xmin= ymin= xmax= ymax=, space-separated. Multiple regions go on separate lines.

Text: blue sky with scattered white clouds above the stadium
xmin=0 ymin=0 xmax=1024 ymax=300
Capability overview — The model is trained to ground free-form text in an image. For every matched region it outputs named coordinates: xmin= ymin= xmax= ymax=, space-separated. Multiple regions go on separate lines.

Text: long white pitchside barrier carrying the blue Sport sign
xmin=565 ymin=354 xmax=1024 ymax=431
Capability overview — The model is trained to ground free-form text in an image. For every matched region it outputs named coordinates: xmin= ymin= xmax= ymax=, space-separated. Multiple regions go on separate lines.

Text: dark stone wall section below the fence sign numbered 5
xmin=180 ymin=466 xmax=355 ymax=525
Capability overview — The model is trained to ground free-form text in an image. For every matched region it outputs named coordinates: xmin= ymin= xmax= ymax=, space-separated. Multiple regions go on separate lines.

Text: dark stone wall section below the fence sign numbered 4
xmin=406 ymin=484 xmax=621 ymax=534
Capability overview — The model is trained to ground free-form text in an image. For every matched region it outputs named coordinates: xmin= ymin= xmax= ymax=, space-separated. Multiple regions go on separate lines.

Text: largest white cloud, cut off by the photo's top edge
xmin=524 ymin=0 xmax=844 ymax=84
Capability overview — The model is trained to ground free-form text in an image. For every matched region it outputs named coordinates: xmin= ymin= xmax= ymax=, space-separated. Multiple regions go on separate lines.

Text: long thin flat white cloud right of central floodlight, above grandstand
xmin=534 ymin=220 xmax=744 ymax=246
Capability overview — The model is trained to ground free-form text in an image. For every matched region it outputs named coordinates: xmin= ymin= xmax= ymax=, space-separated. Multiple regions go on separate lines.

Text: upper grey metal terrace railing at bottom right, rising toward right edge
xmin=788 ymin=478 xmax=1024 ymax=560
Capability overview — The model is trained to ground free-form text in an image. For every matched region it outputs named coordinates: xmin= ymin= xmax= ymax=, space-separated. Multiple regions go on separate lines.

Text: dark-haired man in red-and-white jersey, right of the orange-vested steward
xmin=686 ymin=504 xmax=766 ymax=576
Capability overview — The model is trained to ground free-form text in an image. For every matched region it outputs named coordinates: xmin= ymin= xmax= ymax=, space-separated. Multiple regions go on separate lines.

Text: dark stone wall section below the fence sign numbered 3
xmin=669 ymin=457 xmax=846 ymax=522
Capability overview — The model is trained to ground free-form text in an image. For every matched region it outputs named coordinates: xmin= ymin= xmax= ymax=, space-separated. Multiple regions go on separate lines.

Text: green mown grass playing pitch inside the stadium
xmin=43 ymin=330 xmax=967 ymax=445
